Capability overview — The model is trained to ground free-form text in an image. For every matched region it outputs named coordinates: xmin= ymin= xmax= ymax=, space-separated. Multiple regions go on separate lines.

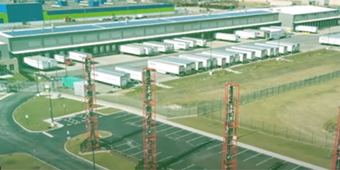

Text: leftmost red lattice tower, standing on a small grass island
xmin=84 ymin=57 xmax=99 ymax=151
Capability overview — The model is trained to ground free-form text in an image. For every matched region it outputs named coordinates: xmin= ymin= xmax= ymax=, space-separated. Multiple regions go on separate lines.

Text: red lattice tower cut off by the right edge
xmin=331 ymin=107 xmax=340 ymax=170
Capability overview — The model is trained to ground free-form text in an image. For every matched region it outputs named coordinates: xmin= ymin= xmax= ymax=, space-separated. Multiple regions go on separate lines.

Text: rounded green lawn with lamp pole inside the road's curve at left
xmin=14 ymin=96 xmax=99 ymax=131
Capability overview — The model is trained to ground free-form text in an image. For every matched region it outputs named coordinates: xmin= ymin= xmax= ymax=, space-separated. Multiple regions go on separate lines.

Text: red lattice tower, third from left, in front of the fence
xmin=222 ymin=83 xmax=240 ymax=170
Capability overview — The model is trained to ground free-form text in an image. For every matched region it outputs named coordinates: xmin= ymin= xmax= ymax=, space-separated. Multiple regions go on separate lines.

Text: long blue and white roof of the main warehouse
xmin=1 ymin=10 xmax=273 ymax=37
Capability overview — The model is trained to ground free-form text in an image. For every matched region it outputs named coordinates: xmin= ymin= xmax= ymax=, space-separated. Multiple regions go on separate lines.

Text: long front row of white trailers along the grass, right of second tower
xmin=148 ymin=41 xmax=300 ymax=77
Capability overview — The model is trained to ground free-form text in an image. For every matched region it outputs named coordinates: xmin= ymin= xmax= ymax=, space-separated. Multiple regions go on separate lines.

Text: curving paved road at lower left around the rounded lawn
xmin=0 ymin=92 xmax=105 ymax=170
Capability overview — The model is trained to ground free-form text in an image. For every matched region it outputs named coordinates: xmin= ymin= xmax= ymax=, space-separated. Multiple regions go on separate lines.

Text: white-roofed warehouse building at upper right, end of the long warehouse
xmin=269 ymin=6 xmax=340 ymax=28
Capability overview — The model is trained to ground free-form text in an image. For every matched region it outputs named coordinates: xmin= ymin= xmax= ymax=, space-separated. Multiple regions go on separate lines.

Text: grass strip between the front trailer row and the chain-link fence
xmin=125 ymin=50 xmax=340 ymax=105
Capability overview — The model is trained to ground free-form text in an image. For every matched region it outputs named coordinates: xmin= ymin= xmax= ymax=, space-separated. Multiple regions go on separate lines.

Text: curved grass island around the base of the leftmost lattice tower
xmin=66 ymin=131 xmax=136 ymax=170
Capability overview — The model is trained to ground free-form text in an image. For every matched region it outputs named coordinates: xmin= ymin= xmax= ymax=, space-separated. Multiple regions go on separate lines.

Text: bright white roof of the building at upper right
xmin=271 ymin=6 xmax=339 ymax=15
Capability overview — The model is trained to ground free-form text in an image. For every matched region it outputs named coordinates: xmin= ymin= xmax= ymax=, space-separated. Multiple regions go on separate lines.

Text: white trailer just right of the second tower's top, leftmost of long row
xmin=148 ymin=59 xmax=186 ymax=77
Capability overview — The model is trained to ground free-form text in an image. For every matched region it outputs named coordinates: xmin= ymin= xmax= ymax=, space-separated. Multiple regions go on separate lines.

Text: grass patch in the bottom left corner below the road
xmin=0 ymin=154 xmax=57 ymax=170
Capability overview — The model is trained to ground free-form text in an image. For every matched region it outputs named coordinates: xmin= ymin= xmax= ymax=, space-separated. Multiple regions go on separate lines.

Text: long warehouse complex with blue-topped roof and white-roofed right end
xmin=0 ymin=6 xmax=339 ymax=74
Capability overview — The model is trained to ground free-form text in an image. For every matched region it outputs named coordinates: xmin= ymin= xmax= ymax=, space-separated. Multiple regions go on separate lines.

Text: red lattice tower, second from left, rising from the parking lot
xmin=142 ymin=68 xmax=157 ymax=170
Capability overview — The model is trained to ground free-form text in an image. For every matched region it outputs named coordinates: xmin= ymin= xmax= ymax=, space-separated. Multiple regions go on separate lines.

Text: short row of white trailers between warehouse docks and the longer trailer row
xmin=119 ymin=37 xmax=207 ymax=56
